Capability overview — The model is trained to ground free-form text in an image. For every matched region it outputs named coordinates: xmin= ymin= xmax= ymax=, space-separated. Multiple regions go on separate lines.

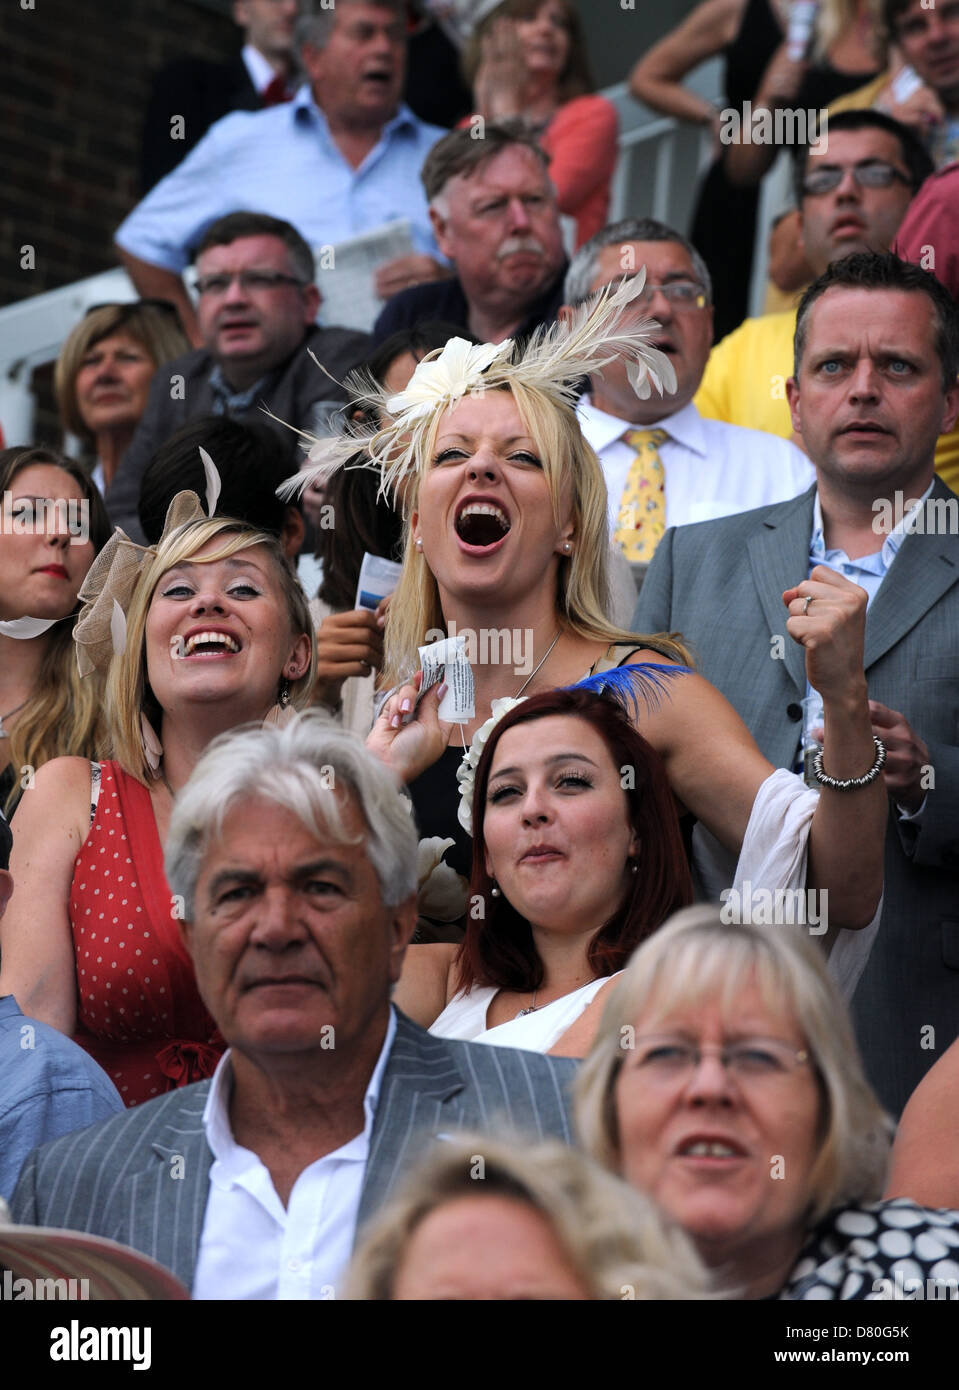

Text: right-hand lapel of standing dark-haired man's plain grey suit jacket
xmin=866 ymin=478 xmax=959 ymax=671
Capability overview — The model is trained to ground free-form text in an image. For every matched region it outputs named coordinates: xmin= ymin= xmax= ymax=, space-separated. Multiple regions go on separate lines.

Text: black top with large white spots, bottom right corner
xmin=780 ymin=1197 xmax=959 ymax=1301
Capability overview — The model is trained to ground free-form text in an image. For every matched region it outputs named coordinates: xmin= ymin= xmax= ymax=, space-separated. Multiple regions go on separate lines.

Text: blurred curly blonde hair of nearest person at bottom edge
xmin=346 ymin=1134 xmax=710 ymax=1300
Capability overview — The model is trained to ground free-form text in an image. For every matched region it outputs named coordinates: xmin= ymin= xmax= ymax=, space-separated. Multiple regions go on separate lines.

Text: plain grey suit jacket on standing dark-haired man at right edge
xmin=634 ymin=478 xmax=959 ymax=1113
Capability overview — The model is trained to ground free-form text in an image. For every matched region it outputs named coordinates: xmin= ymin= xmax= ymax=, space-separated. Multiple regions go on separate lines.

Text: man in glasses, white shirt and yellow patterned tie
xmin=560 ymin=217 xmax=813 ymax=563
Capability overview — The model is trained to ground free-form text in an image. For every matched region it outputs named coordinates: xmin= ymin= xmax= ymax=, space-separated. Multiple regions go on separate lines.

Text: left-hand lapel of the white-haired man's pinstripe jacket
xmin=115 ymin=1081 xmax=213 ymax=1289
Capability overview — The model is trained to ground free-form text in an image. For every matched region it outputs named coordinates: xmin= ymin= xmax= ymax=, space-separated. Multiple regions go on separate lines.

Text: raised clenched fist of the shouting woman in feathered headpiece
xmin=782 ymin=564 xmax=867 ymax=709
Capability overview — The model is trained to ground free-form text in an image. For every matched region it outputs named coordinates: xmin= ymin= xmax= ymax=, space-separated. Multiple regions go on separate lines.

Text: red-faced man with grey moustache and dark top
xmin=374 ymin=117 xmax=566 ymax=343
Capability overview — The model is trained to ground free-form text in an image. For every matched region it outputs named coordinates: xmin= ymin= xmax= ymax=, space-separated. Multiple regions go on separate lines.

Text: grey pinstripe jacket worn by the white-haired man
xmin=11 ymin=1012 xmax=575 ymax=1289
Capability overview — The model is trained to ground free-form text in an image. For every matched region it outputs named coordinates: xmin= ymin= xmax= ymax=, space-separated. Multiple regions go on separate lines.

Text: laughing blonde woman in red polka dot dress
xmin=0 ymin=511 xmax=315 ymax=1105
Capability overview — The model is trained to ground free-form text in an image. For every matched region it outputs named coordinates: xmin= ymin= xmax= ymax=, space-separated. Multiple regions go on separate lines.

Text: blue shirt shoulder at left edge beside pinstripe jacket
xmin=0 ymin=994 xmax=124 ymax=1201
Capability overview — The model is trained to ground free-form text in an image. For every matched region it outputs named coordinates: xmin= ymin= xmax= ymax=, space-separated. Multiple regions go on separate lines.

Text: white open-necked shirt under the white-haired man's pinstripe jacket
xmin=193 ymin=1008 xmax=396 ymax=1300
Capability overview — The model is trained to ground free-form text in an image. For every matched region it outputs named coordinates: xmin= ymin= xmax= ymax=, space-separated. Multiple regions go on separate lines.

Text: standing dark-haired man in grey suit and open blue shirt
xmin=634 ymin=253 xmax=959 ymax=1113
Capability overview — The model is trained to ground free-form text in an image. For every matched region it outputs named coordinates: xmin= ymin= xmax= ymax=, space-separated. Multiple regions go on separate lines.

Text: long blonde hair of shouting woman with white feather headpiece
xmin=382 ymin=381 xmax=689 ymax=687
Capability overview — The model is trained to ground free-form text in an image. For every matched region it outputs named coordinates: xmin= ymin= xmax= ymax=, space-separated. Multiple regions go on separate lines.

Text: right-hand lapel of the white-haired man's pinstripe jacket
xmin=356 ymin=1012 xmax=466 ymax=1230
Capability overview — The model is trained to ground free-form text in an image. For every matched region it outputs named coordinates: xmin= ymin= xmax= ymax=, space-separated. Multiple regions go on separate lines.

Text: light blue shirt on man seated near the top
xmin=117 ymin=85 xmax=448 ymax=274
